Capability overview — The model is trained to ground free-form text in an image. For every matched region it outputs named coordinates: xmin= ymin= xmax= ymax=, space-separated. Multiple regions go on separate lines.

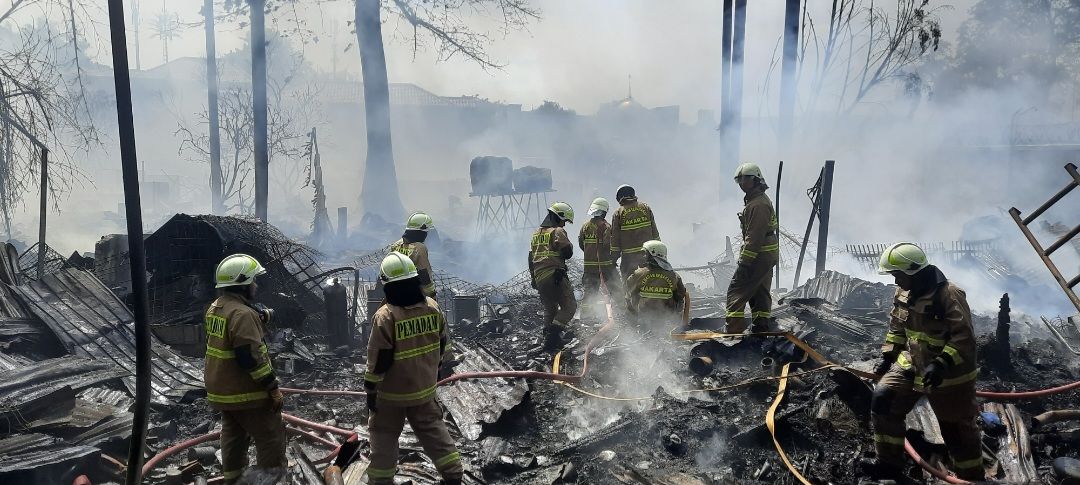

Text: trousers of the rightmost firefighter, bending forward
xmin=870 ymin=364 xmax=986 ymax=482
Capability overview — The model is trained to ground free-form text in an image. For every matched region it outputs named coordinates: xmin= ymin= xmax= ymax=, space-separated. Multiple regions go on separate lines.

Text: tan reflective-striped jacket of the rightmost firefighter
xmin=881 ymin=283 xmax=978 ymax=390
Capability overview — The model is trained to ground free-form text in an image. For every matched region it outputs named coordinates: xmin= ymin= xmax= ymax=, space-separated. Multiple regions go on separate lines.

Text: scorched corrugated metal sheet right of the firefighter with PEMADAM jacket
xmin=438 ymin=342 xmax=529 ymax=441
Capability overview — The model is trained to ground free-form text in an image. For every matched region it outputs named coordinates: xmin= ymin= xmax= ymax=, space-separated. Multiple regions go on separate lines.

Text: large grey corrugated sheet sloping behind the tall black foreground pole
xmin=15 ymin=269 xmax=202 ymax=402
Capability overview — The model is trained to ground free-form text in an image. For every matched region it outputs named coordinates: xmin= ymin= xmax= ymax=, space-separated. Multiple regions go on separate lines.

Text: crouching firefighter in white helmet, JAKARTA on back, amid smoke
xmin=626 ymin=241 xmax=690 ymax=335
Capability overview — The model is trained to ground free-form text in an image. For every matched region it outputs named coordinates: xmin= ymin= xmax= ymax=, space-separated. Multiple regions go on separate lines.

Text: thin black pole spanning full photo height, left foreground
xmin=109 ymin=0 xmax=151 ymax=485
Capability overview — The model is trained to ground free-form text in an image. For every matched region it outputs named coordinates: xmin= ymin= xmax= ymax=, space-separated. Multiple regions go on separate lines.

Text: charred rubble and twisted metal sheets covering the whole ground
xmin=0 ymin=216 xmax=1080 ymax=485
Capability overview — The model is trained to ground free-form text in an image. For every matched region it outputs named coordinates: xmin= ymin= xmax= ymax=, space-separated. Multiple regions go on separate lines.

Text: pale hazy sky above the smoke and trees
xmin=127 ymin=0 xmax=975 ymax=121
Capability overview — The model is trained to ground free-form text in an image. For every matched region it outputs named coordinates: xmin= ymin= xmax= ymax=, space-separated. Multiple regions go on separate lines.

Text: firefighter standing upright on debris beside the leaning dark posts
xmin=727 ymin=163 xmax=780 ymax=334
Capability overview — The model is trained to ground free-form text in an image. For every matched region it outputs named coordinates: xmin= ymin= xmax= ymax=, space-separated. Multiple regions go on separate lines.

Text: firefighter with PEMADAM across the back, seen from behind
xmin=364 ymin=253 xmax=463 ymax=485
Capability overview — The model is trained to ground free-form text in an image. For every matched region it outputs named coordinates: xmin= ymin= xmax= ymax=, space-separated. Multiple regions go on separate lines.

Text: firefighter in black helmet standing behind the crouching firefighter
xmin=611 ymin=185 xmax=660 ymax=281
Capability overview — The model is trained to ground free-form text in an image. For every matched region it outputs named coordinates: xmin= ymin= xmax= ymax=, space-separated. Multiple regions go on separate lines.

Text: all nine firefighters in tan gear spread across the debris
xmin=205 ymin=163 xmax=984 ymax=485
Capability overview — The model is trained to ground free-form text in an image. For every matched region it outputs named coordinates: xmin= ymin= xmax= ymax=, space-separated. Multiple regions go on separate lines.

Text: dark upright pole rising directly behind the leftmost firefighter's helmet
xmin=248 ymin=0 xmax=270 ymax=223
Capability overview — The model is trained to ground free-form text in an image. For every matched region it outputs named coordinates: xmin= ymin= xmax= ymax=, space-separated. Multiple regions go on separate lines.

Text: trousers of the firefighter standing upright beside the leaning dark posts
xmin=727 ymin=257 xmax=777 ymax=334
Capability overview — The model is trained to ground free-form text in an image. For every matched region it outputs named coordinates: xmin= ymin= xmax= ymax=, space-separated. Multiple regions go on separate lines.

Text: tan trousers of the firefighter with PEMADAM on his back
xmin=367 ymin=400 xmax=464 ymax=485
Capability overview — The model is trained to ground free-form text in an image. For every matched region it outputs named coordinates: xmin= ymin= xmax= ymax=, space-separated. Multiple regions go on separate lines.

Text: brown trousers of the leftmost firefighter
xmin=221 ymin=407 xmax=286 ymax=484
